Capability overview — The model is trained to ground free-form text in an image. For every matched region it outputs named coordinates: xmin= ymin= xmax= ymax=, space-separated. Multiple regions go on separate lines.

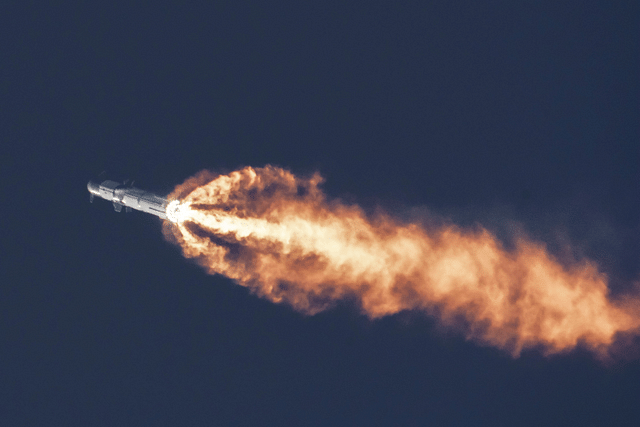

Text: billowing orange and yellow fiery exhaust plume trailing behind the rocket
xmin=165 ymin=166 xmax=640 ymax=357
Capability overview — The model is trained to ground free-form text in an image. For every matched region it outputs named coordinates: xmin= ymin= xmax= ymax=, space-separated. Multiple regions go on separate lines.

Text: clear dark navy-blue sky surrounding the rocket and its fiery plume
xmin=0 ymin=0 xmax=640 ymax=426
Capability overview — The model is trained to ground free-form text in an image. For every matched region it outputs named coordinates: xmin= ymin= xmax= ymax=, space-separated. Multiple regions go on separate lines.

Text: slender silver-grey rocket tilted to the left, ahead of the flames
xmin=87 ymin=180 xmax=179 ymax=222
